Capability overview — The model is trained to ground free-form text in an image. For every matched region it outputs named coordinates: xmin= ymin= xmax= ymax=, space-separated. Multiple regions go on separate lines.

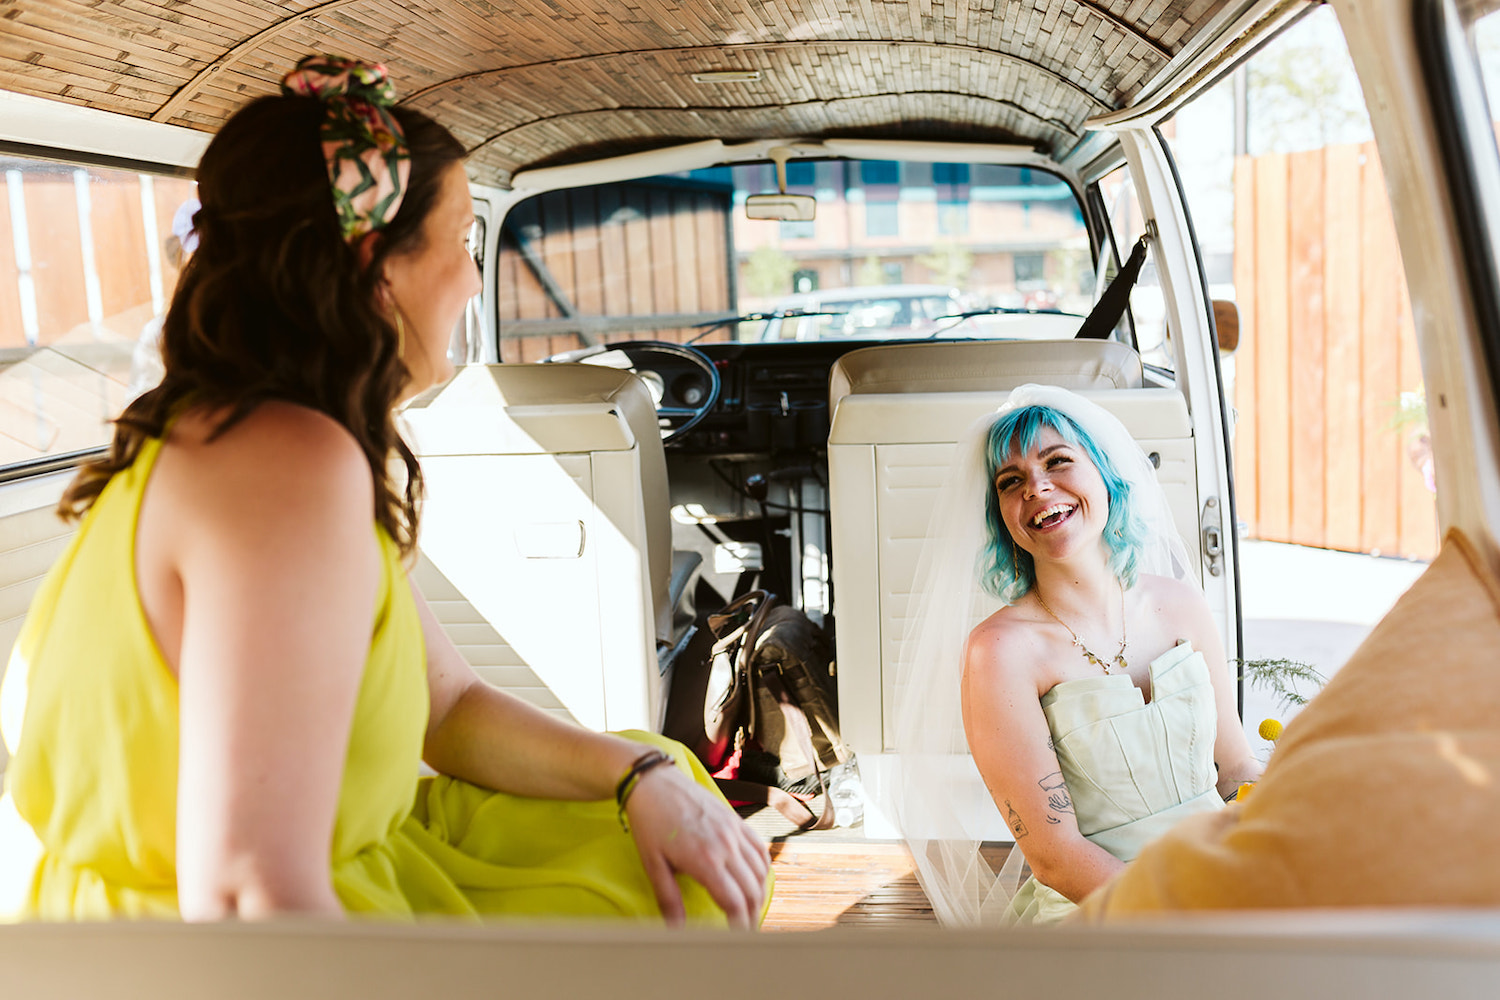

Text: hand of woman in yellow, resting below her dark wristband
xmin=626 ymin=766 xmax=771 ymax=930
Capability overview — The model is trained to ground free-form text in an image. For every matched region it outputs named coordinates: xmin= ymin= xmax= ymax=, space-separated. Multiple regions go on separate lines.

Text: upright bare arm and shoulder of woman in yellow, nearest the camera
xmin=156 ymin=403 xmax=380 ymax=919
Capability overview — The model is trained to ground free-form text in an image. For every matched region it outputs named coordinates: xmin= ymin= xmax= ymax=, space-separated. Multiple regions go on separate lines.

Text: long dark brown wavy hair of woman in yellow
xmin=57 ymin=96 xmax=464 ymax=555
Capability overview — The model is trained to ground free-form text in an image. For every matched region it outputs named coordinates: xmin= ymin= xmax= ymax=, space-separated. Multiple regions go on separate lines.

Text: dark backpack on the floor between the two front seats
xmin=663 ymin=591 xmax=852 ymax=829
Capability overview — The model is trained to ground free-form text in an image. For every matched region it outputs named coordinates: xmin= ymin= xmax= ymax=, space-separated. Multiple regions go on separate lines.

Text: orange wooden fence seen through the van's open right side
xmin=1233 ymin=142 xmax=1437 ymax=559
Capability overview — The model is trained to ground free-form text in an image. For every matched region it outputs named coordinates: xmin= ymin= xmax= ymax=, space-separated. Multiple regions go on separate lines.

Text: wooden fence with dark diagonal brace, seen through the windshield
xmin=498 ymin=183 xmax=734 ymax=361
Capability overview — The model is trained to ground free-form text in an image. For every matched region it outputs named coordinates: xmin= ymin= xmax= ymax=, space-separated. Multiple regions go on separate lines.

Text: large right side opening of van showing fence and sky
xmin=1161 ymin=6 xmax=1440 ymax=743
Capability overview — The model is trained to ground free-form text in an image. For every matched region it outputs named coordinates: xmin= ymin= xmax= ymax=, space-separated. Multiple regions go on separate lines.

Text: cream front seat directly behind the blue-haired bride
xmin=828 ymin=340 xmax=1197 ymax=841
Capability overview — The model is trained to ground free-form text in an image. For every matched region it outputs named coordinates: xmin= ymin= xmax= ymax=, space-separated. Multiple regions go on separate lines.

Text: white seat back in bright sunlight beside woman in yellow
xmin=405 ymin=364 xmax=672 ymax=729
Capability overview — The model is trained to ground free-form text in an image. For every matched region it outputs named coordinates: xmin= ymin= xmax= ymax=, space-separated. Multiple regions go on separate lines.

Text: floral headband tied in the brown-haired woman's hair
xmin=282 ymin=55 xmax=411 ymax=243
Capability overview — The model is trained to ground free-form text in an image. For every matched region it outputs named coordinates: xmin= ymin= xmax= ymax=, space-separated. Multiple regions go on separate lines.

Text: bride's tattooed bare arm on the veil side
xmin=963 ymin=618 xmax=1125 ymax=903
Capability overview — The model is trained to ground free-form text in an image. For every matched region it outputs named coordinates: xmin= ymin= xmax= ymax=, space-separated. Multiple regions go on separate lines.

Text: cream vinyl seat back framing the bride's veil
xmin=828 ymin=342 xmax=1197 ymax=754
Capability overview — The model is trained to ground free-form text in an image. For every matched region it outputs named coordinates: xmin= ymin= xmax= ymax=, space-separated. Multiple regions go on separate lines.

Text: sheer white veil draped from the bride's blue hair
xmin=882 ymin=385 xmax=1196 ymax=927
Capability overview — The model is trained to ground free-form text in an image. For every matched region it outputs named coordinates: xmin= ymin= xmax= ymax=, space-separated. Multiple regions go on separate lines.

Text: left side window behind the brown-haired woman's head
xmin=0 ymin=157 xmax=197 ymax=468
